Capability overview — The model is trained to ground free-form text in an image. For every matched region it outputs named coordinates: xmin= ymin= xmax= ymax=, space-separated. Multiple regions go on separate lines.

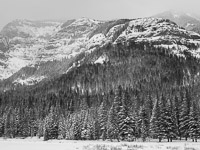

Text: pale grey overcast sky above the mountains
xmin=0 ymin=0 xmax=200 ymax=29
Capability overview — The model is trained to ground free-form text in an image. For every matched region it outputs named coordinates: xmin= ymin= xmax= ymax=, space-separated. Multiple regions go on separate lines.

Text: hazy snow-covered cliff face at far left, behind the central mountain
xmin=0 ymin=20 xmax=61 ymax=79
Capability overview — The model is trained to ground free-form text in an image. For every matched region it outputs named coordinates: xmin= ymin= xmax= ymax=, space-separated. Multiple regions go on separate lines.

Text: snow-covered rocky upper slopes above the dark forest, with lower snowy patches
xmin=0 ymin=18 xmax=200 ymax=84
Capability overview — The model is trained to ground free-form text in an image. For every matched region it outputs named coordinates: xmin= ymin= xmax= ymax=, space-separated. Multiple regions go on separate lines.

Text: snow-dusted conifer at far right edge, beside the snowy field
xmin=189 ymin=102 xmax=200 ymax=142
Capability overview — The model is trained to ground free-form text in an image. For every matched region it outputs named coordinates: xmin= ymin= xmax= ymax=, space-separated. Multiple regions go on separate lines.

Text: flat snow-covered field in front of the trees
xmin=0 ymin=138 xmax=200 ymax=150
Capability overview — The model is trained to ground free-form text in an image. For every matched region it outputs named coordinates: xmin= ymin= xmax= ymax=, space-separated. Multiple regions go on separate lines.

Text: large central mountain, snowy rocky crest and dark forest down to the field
xmin=0 ymin=18 xmax=200 ymax=141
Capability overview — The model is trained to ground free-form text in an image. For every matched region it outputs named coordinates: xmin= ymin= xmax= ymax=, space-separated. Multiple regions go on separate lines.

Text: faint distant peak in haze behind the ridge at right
xmin=153 ymin=11 xmax=200 ymax=33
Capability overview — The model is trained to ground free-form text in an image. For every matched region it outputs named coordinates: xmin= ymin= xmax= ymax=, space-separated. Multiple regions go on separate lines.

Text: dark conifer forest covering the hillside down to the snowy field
xmin=0 ymin=37 xmax=200 ymax=141
